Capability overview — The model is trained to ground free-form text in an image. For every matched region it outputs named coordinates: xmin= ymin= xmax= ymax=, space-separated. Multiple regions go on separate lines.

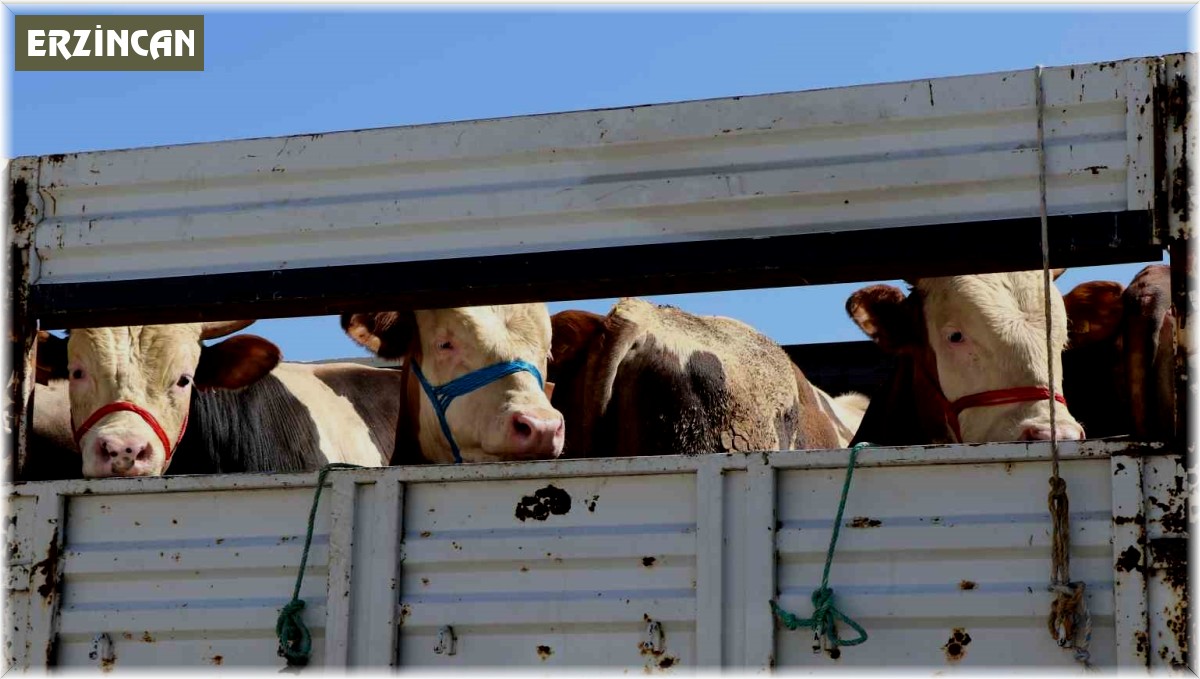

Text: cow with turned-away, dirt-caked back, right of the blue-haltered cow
xmin=550 ymin=299 xmax=839 ymax=457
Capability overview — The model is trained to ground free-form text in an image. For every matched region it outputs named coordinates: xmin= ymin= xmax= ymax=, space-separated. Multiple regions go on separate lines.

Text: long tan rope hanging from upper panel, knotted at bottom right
xmin=1033 ymin=66 xmax=1092 ymax=667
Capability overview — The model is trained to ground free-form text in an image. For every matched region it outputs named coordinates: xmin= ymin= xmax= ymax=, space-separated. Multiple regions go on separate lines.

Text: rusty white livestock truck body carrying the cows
xmin=2 ymin=54 xmax=1196 ymax=673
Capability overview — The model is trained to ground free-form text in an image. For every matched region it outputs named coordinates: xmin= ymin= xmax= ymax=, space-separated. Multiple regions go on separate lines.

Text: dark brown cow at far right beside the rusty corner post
xmin=1063 ymin=264 xmax=1175 ymax=440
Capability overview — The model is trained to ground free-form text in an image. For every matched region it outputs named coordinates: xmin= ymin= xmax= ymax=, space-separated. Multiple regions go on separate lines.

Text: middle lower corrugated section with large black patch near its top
xmin=400 ymin=474 xmax=696 ymax=668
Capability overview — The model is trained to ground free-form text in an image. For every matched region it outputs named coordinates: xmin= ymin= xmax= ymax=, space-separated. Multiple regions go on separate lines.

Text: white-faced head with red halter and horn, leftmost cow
xmin=38 ymin=320 xmax=280 ymax=477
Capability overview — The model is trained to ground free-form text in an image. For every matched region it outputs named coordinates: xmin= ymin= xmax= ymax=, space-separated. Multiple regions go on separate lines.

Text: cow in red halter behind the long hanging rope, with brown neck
xmin=846 ymin=270 xmax=1084 ymax=445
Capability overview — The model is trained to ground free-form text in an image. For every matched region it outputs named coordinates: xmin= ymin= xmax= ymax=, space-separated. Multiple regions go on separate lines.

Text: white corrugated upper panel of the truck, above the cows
xmin=14 ymin=59 xmax=1156 ymax=284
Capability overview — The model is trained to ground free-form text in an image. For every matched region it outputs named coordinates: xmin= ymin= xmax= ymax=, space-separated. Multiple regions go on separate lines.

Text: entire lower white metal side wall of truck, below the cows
xmin=5 ymin=441 xmax=1188 ymax=672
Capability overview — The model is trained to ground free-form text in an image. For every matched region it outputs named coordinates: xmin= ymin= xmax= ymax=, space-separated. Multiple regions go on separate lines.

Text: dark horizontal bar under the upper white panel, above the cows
xmin=30 ymin=211 xmax=1163 ymax=329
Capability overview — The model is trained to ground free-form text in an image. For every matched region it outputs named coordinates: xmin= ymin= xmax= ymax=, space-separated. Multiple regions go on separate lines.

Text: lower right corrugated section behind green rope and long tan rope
xmin=778 ymin=460 xmax=1116 ymax=668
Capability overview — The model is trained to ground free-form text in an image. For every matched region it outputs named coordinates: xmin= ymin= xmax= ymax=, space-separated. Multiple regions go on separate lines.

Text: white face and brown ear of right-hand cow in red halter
xmin=846 ymin=270 xmax=1084 ymax=443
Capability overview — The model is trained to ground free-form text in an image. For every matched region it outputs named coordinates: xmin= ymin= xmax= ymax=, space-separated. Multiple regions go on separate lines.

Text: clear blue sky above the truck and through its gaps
xmin=5 ymin=4 xmax=1190 ymax=360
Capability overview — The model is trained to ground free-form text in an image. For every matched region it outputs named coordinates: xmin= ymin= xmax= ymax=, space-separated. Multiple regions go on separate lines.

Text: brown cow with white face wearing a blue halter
xmin=341 ymin=304 xmax=566 ymax=464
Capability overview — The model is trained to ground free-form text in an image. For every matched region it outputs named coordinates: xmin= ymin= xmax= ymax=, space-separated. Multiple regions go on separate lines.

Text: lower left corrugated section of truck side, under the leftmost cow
xmin=58 ymin=488 xmax=329 ymax=668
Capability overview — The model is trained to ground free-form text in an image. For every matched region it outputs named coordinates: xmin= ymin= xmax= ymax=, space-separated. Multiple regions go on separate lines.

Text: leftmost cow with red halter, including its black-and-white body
xmin=32 ymin=320 xmax=400 ymax=477
